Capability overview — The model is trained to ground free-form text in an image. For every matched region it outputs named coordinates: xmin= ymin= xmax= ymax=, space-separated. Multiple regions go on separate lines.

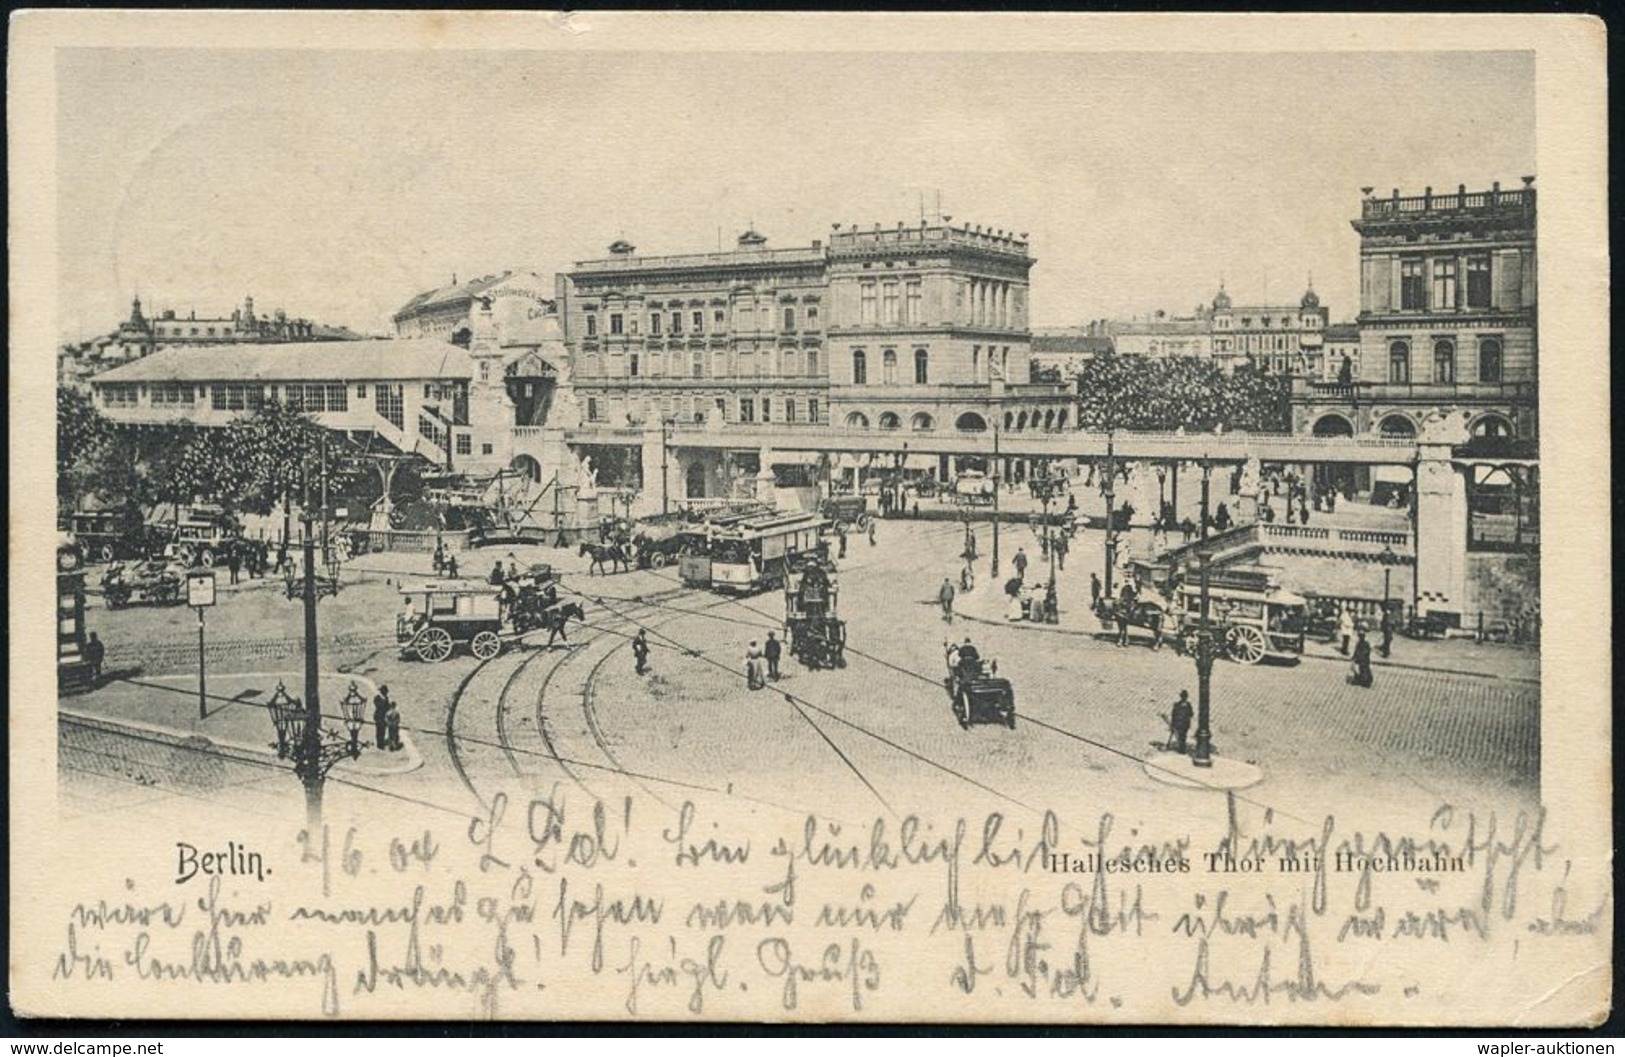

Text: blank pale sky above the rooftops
xmin=57 ymin=49 xmax=1536 ymax=338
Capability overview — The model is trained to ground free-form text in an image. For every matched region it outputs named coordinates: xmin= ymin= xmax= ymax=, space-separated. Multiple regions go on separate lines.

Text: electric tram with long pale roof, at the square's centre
xmin=678 ymin=514 xmax=829 ymax=592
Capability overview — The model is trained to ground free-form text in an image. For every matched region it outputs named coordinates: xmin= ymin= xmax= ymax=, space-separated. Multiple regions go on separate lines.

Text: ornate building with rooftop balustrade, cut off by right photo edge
xmin=1294 ymin=177 xmax=1539 ymax=441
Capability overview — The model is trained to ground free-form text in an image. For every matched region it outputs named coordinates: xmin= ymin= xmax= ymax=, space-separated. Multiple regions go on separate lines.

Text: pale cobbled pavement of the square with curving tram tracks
xmin=60 ymin=522 xmax=1539 ymax=824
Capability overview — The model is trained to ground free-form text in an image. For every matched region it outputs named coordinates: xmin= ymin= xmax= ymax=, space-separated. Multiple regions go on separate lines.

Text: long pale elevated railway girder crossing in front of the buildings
xmin=566 ymin=424 xmax=1417 ymax=467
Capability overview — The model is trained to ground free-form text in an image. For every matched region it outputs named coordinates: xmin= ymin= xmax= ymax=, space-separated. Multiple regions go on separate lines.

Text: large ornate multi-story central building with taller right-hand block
xmin=557 ymin=223 xmax=1073 ymax=429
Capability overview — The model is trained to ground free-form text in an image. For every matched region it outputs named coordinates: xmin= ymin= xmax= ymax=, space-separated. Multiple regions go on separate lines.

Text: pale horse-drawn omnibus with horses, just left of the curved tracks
xmin=395 ymin=566 xmax=587 ymax=663
